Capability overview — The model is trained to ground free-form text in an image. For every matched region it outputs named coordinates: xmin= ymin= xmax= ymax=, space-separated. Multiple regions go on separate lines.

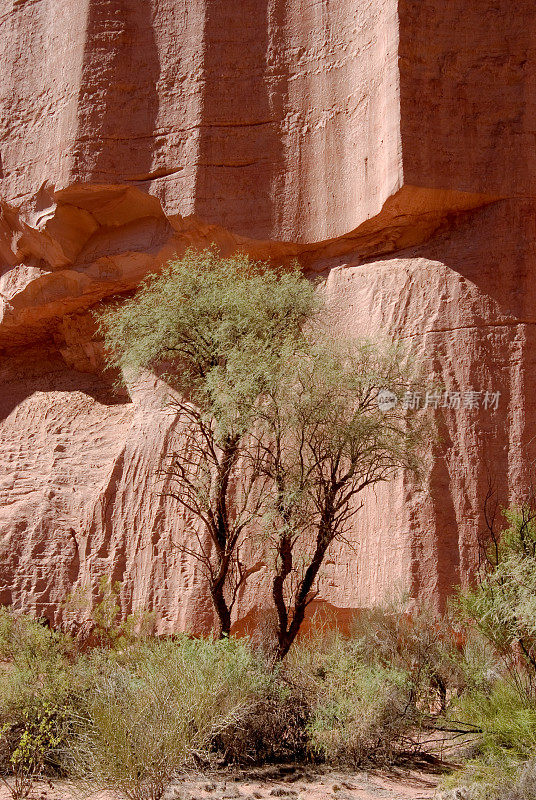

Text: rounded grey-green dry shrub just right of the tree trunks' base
xmin=287 ymin=601 xmax=472 ymax=766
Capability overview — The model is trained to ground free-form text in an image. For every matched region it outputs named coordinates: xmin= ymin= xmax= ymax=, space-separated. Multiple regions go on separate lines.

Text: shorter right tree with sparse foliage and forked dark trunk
xmin=255 ymin=337 xmax=431 ymax=659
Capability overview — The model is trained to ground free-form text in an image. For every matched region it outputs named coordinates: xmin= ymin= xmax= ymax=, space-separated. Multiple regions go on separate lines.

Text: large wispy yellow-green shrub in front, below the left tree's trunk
xmin=70 ymin=637 xmax=266 ymax=800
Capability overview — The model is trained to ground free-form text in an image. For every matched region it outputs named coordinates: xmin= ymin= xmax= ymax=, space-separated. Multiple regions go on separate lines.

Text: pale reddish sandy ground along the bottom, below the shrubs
xmin=0 ymin=766 xmax=440 ymax=800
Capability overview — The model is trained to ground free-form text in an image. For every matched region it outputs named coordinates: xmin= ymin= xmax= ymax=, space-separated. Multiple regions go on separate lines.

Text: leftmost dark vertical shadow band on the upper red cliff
xmin=73 ymin=0 xmax=160 ymax=183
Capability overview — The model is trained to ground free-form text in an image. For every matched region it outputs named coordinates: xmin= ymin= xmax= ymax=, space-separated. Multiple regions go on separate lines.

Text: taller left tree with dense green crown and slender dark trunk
xmin=99 ymin=250 xmax=320 ymax=636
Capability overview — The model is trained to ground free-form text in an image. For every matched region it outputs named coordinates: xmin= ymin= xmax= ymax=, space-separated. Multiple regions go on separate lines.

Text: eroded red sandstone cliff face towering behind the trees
xmin=0 ymin=0 xmax=536 ymax=631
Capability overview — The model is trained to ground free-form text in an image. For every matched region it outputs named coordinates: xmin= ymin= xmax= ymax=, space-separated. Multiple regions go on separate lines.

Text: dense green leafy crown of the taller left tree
xmin=99 ymin=249 xmax=321 ymax=435
